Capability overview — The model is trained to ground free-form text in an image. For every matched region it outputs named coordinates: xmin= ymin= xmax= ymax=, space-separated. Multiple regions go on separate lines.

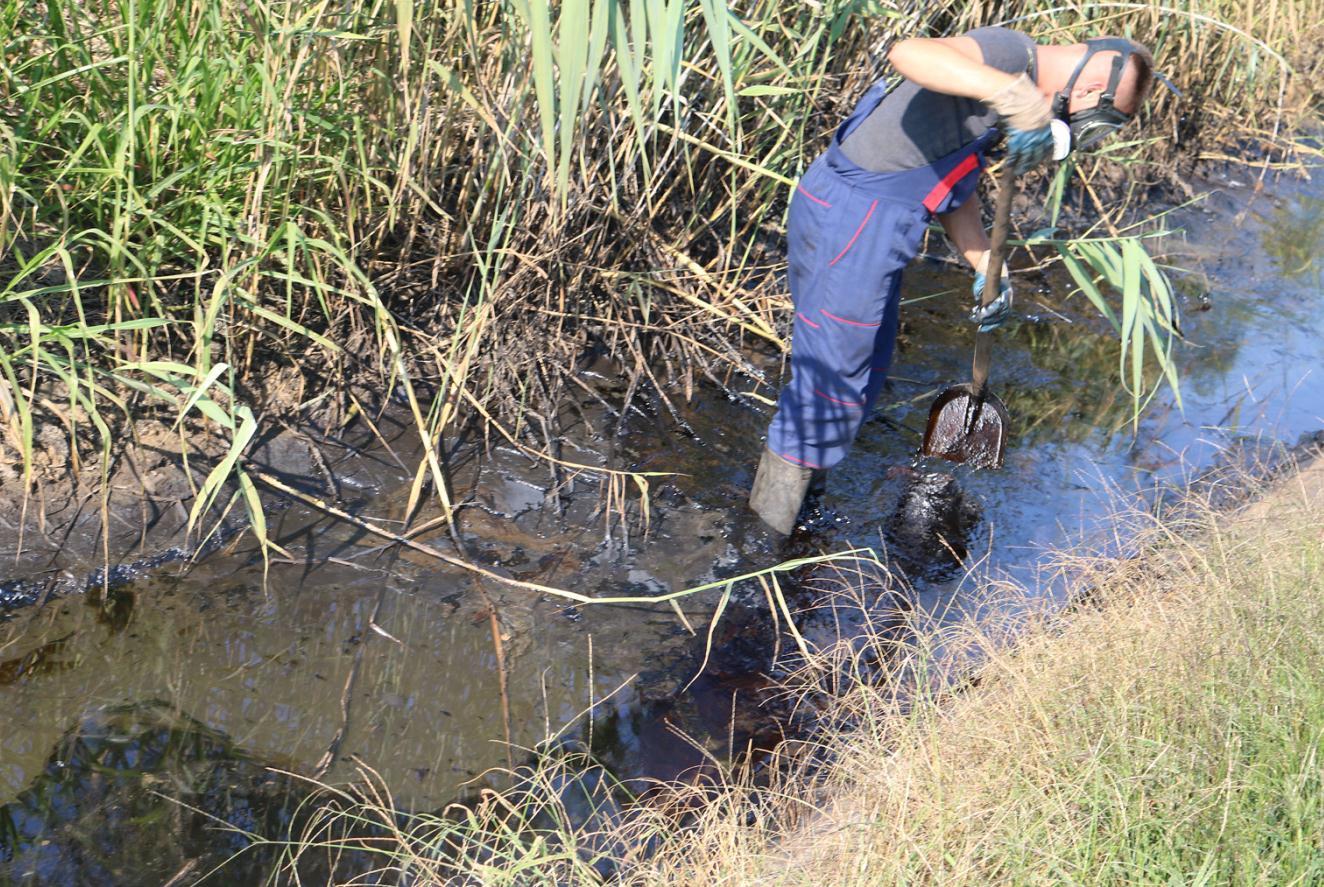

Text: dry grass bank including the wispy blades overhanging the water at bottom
xmin=263 ymin=459 xmax=1324 ymax=887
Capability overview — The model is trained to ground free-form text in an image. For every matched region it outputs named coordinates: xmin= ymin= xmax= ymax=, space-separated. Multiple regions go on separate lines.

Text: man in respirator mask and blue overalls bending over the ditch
xmin=749 ymin=28 xmax=1153 ymax=535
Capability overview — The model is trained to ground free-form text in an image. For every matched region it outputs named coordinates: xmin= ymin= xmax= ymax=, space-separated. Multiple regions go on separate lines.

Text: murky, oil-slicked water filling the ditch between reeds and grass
xmin=0 ymin=164 xmax=1324 ymax=884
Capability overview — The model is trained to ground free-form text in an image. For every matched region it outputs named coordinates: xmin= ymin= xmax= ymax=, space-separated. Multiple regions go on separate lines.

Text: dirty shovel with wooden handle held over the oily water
xmin=922 ymin=160 xmax=1016 ymax=469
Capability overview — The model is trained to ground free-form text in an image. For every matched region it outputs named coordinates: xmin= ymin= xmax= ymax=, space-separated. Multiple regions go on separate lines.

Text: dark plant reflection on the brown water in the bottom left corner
xmin=0 ymin=703 xmax=367 ymax=886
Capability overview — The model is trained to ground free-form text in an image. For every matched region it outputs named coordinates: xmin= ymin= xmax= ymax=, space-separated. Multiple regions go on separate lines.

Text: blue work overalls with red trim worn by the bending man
xmin=768 ymin=82 xmax=998 ymax=469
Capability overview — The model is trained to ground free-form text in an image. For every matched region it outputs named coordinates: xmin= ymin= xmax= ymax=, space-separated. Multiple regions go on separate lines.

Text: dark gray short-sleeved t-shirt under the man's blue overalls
xmin=841 ymin=28 xmax=1037 ymax=172
